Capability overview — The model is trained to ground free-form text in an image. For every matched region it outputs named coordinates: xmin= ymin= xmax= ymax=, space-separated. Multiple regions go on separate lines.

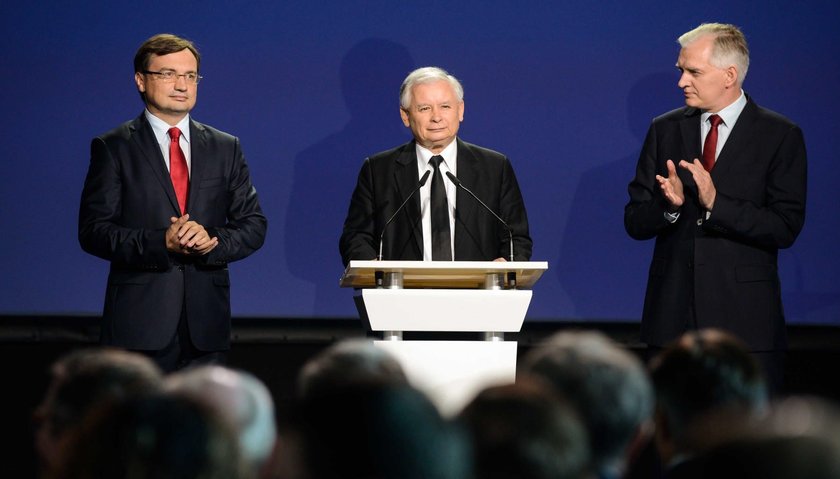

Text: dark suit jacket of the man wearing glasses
xmin=79 ymin=114 xmax=267 ymax=351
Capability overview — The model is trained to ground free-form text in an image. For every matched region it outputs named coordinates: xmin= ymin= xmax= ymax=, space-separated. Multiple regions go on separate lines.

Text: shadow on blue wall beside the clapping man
xmin=555 ymin=72 xmax=680 ymax=320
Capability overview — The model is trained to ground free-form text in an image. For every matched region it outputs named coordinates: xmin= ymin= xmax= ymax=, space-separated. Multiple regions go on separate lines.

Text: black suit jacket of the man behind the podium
xmin=339 ymin=139 xmax=532 ymax=265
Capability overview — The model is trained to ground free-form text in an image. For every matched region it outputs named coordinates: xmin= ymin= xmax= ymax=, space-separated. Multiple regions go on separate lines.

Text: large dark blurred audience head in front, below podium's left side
xmin=293 ymin=382 xmax=472 ymax=479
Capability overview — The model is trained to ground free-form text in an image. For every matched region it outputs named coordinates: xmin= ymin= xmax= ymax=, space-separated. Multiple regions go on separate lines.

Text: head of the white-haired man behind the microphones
xmin=400 ymin=67 xmax=464 ymax=153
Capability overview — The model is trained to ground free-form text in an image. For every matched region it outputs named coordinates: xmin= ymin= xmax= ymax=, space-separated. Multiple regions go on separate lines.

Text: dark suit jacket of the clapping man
xmin=624 ymin=97 xmax=807 ymax=351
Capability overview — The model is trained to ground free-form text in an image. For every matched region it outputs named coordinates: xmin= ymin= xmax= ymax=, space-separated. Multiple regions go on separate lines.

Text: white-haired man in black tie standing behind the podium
xmin=339 ymin=67 xmax=532 ymax=265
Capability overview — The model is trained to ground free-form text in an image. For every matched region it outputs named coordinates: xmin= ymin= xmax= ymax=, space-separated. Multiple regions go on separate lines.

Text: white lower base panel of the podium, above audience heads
xmin=374 ymin=341 xmax=516 ymax=417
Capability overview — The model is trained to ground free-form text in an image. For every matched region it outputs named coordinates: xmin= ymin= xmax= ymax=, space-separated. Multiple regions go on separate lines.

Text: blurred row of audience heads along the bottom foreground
xmin=35 ymin=330 xmax=840 ymax=479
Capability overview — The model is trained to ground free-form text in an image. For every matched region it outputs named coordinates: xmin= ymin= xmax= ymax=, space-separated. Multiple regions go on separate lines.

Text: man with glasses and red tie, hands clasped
xmin=79 ymin=34 xmax=267 ymax=371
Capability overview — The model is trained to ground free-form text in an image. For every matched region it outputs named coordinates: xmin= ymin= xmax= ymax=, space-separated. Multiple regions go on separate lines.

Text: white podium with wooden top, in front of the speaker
xmin=340 ymin=261 xmax=548 ymax=416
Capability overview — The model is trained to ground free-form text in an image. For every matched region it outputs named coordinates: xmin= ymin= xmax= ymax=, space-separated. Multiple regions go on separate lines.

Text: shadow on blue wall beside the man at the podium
xmin=284 ymin=38 xmax=414 ymax=316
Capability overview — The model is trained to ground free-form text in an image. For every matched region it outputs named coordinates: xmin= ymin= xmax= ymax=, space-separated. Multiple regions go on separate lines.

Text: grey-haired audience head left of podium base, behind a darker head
xmin=297 ymin=339 xmax=408 ymax=398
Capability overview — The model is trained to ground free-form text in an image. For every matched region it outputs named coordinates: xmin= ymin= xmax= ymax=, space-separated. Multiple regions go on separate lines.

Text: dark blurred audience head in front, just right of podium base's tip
xmin=459 ymin=380 xmax=591 ymax=479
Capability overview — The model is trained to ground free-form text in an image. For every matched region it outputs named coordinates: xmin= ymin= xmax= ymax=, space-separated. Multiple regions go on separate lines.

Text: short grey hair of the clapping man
xmin=677 ymin=23 xmax=750 ymax=85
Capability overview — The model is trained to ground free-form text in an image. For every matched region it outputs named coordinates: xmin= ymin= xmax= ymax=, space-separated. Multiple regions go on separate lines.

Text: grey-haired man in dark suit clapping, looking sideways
xmin=624 ymin=24 xmax=806 ymax=385
